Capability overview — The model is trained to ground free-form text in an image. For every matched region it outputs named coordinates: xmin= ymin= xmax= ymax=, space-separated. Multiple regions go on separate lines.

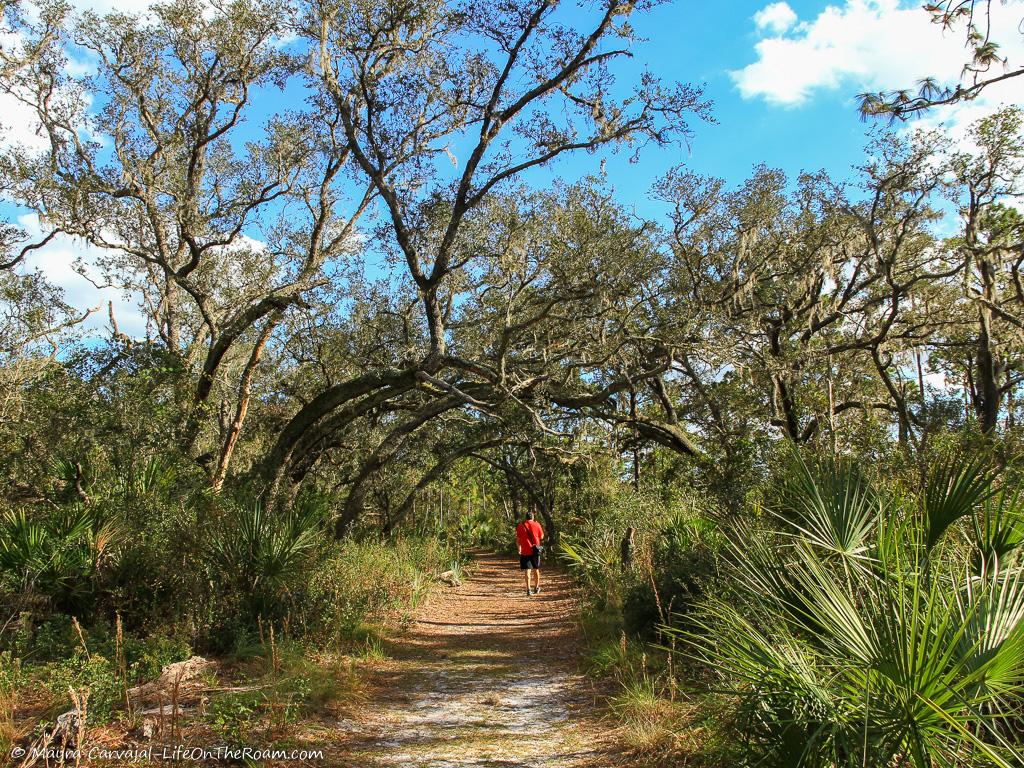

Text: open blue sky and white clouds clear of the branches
xmin=0 ymin=0 xmax=1024 ymax=335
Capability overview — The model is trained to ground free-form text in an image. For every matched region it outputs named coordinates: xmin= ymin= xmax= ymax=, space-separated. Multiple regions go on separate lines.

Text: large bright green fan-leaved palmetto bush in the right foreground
xmin=686 ymin=460 xmax=1024 ymax=768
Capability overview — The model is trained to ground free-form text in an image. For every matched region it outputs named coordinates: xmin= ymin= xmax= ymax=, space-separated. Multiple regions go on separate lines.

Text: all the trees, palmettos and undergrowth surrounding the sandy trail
xmin=0 ymin=0 xmax=1024 ymax=768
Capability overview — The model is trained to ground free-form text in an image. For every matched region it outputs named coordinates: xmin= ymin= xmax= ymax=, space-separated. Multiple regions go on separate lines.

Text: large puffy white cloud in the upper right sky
xmin=730 ymin=0 xmax=1024 ymax=106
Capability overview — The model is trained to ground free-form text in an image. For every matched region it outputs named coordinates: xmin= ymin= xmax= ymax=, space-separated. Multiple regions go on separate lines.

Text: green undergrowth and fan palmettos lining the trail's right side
xmin=562 ymin=444 xmax=1024 ymax=768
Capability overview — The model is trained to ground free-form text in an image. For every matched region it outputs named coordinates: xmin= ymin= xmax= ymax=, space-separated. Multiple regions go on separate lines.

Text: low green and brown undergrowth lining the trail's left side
xmin=0 ymin=489 xmax=464 ymax=751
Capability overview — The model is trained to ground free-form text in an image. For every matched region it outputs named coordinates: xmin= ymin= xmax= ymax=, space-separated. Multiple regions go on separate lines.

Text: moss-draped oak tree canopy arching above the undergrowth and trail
xmin=0 ymin=0 xmax=1024 ymax=536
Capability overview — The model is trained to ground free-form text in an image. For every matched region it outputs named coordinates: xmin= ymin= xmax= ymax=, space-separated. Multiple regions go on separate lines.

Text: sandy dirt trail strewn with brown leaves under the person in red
xmin=346 ymin=554 xmax=620 ymax=768
